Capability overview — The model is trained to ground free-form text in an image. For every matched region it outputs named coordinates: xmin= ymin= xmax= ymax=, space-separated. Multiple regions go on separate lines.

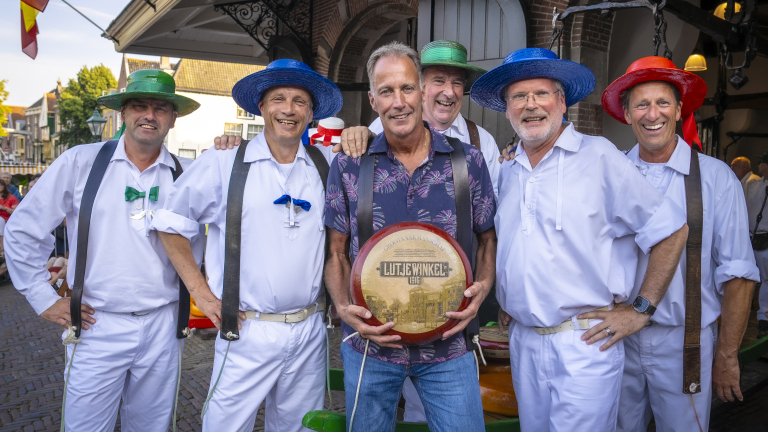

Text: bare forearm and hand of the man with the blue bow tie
xmin=157 ymin=235 xmax=245 ymax=328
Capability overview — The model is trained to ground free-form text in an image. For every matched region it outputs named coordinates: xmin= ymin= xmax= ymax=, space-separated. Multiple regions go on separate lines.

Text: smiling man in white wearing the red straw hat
xmin=600 ymin=57 xmax=760 ymax=432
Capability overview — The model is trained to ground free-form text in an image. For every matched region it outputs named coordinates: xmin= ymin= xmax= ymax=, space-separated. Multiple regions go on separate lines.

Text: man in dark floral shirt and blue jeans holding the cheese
xmin=325 ymin=43 xmax=496 ymax=432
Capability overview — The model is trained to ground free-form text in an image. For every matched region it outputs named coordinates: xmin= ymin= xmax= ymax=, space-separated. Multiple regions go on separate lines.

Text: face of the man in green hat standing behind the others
xmin=422 ymin=66 xmax=466 ymax=130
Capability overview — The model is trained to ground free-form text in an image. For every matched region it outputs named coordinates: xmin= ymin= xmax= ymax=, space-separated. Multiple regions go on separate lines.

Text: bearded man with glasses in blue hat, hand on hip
xmin=471 ymin=48 xmax=687 ymax=431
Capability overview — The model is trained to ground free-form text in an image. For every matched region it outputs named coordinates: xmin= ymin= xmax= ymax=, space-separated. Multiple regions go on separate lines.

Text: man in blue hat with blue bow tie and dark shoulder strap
xmin=153 ymin=59 xmax=342 ymax=432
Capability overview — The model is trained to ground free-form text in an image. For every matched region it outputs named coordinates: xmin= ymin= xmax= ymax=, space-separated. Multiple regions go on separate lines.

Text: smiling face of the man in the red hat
xmin=624 ymin=81 xmax=683 ymax=153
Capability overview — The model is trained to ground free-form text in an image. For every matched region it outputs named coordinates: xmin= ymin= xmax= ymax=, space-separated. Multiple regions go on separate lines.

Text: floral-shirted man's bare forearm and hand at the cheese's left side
xmin=324 ymin=230 xmax=402 ymax=348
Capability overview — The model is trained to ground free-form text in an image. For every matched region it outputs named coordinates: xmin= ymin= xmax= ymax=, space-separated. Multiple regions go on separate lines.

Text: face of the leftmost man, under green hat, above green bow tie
xmin=121 ymin=99 xmax=178 ymax=146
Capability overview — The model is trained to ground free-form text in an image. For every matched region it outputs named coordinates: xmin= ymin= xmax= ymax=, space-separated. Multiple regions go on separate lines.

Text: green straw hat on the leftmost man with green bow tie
xmin=96 ymin=69 xmax=200 ymax=117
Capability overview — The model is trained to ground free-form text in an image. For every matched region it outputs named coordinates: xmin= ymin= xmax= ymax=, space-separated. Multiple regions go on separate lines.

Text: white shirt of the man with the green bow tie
xmin=4 ymin=137 xmax=203 ymax=314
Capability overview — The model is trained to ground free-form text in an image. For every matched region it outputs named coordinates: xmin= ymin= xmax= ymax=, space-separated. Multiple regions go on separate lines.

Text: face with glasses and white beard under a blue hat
xmin=505 ymin=78 xmax=566 ymax=149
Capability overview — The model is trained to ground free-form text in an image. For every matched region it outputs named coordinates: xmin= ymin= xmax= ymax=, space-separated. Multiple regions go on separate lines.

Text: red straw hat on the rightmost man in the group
xmin=602 ymin=68 xmax=707 ymax=124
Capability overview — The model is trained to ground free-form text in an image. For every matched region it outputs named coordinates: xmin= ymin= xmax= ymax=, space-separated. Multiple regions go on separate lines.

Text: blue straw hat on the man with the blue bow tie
xmin=232 ymin=59 xmax=344 ymax=120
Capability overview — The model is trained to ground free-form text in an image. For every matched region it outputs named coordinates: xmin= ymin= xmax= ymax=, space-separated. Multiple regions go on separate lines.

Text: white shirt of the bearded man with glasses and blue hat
xmin=495 ymin=123 xmax=685 ymax=327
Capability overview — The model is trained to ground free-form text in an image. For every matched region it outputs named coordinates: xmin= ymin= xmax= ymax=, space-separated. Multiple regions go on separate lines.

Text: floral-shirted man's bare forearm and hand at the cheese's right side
xmin=443 ymin=227 xmax=496 ymax=340
